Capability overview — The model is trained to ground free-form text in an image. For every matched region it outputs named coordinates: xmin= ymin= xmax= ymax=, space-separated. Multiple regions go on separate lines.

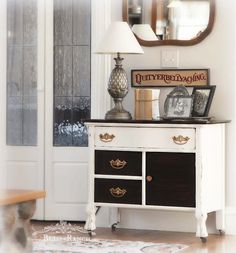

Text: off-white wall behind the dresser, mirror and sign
xmin=105 ymin=0 xmax=236 ymax=234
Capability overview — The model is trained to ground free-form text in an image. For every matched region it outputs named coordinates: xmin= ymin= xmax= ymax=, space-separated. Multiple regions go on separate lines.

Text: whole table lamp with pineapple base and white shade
xmin=96 ymin=22 xmax=144 ymax=120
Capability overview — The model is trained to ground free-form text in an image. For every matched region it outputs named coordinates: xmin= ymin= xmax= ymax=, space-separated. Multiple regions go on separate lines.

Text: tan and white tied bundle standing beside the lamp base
xmin=135 ymin=89 xmax=160 ymax=120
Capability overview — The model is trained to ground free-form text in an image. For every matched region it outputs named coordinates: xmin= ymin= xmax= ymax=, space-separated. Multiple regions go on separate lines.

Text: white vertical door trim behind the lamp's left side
xmin=91 ymin=0 xmax=111 ymax=118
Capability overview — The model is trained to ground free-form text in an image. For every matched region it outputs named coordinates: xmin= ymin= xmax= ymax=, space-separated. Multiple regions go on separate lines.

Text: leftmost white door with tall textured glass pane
xmin=3 ymin=0 xmax=46 ymax=219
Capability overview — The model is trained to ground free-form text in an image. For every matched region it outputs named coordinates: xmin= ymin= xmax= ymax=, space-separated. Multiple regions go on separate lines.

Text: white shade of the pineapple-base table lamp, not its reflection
xmin=96 ymin=21 xmax=144 ymax=54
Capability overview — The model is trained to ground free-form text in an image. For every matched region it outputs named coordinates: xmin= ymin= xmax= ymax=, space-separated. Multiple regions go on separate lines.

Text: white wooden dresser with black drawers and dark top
xmin=85 ymin=120 xmax=226 ymax=242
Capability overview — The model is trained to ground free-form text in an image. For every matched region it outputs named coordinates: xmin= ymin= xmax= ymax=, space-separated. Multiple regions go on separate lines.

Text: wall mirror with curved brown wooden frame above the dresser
xmin=123 ymin=0 xmax=215 ymax=46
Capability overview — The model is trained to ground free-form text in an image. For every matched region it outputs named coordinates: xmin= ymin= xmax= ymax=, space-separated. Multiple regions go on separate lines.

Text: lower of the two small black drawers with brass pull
xmin=95 ymin=178 xmax=142 ymax=205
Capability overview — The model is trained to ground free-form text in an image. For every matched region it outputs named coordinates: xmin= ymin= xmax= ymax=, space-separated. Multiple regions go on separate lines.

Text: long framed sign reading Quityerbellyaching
xmin=131 ymin=69 xmax=210 ymax=87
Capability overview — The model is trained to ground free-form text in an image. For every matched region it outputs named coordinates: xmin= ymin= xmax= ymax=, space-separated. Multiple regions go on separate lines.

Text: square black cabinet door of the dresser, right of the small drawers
xmin=146 ymin=152 xmax=195 ymax=207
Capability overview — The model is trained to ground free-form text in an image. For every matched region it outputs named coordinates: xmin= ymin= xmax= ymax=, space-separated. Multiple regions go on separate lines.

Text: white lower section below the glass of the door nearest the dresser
xmin=45 ymin=147 xmax=88 ymax=221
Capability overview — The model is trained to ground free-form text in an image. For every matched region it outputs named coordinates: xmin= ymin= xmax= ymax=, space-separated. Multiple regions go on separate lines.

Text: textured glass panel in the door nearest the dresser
xmin=53 ymin=0 xmax=91 ymax=147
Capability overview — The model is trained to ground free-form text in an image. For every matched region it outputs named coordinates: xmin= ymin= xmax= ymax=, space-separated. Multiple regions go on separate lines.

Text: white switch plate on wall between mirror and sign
xmin=161 ymin=50 xmax=179 ymax=68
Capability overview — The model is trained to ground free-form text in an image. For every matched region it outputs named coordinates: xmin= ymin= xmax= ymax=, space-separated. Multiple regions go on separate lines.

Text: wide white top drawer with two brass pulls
xmin=95 ymin=127 xmax=195 ymax=150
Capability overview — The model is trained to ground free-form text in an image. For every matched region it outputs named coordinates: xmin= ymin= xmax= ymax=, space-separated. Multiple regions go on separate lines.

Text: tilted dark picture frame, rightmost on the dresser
xmin=192 ymin=85 xmax=216 ymax=117
